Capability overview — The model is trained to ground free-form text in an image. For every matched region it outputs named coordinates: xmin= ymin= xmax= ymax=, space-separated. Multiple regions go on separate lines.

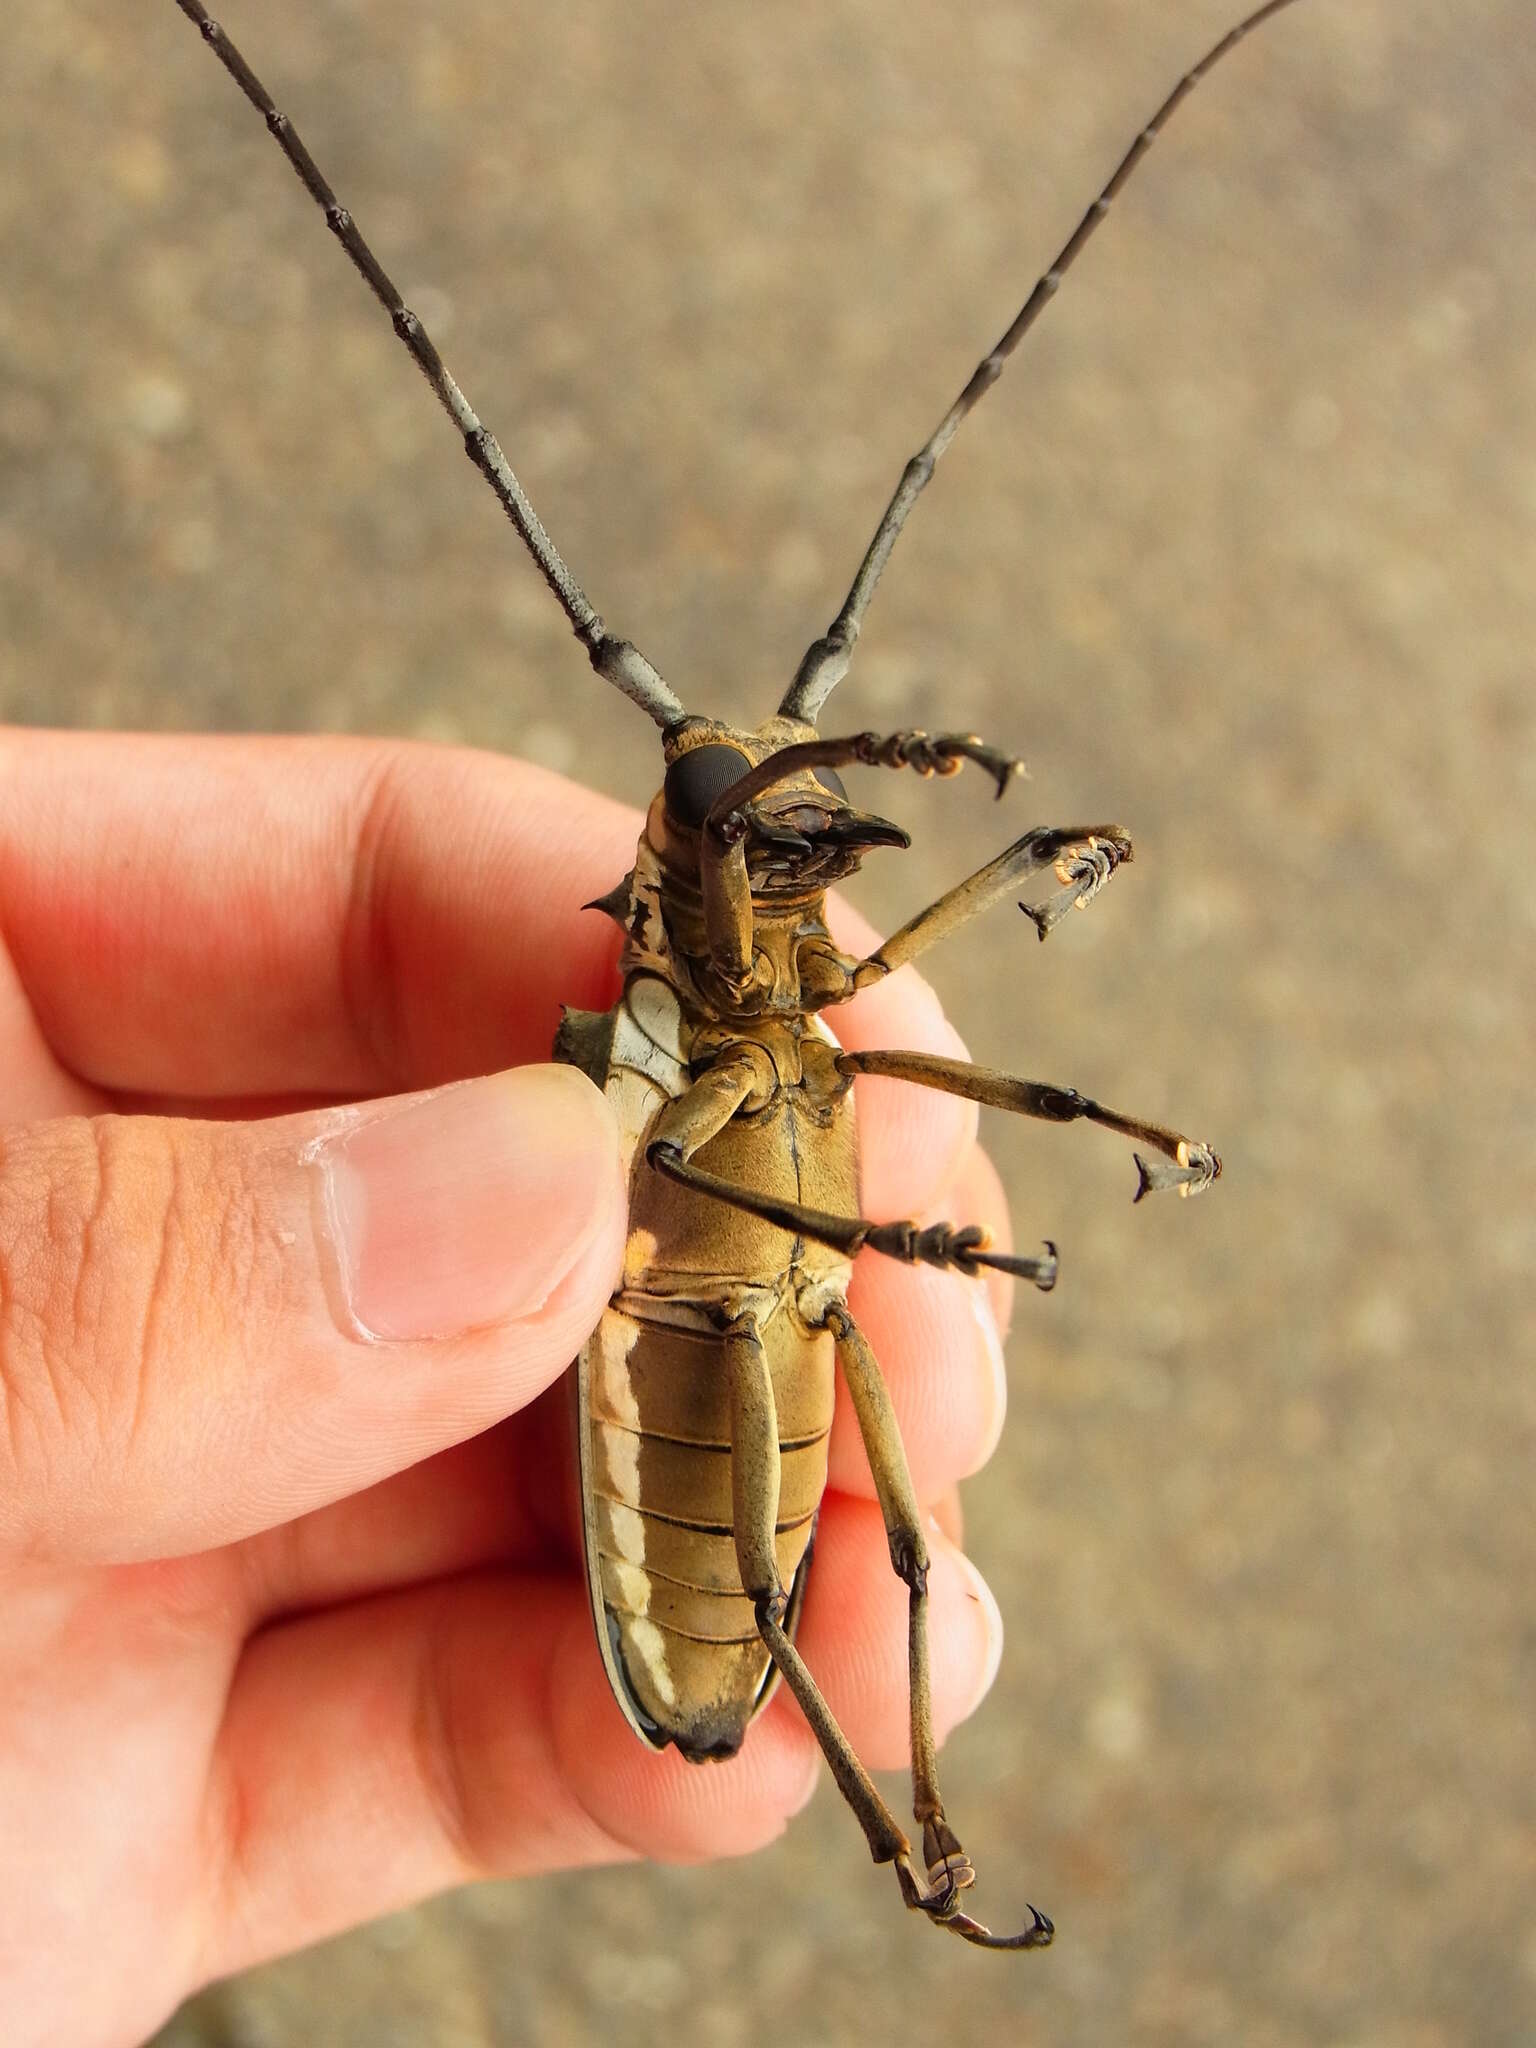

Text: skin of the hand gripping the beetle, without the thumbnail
xmin=0 ymin=733 xmax=1024 ymax=2048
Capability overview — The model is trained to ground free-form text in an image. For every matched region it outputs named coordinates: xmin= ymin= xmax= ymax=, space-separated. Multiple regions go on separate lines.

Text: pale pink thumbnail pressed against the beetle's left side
xmin=311 ymin=1067 xmax=618 ymax=1339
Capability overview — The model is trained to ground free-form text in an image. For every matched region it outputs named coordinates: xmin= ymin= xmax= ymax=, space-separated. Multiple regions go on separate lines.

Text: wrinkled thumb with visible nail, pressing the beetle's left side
xmin=0 ymin=1067 xmax=625 ymax=1561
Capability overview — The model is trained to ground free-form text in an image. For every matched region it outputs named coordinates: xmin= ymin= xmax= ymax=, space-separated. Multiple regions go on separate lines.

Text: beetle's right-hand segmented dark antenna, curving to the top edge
xmin=778 ymin=0 xmax=1292 ymax=725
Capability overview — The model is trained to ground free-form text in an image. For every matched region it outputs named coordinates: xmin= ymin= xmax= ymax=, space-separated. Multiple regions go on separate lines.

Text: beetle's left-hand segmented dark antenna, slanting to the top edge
xmin=176 ymin=0 xmax=686 ymax=729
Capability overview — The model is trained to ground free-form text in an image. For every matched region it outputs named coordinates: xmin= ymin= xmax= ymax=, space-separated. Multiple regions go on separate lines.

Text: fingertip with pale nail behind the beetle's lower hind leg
xmin=774 ymin=1493 xmax=1004 ymax=1772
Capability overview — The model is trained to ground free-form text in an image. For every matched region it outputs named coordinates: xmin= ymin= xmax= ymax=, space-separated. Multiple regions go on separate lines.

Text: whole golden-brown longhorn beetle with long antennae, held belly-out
xmin=176 ymin=0 xmax=1290 ymax=1950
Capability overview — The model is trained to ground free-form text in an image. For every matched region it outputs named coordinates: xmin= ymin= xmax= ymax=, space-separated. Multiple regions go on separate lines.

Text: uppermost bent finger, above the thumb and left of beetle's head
xmin=0 ymin=731 xmax=637 ymax=1100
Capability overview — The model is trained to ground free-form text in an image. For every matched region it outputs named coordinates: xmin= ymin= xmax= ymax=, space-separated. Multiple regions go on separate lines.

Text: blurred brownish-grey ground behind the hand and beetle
xmin=0 ymin=0 xmax=1536 ymax=2048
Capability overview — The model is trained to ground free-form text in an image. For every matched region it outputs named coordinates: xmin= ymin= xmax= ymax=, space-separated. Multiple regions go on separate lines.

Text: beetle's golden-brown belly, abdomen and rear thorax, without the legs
xmin=561 ymin=979 xmax=856 ymax=1759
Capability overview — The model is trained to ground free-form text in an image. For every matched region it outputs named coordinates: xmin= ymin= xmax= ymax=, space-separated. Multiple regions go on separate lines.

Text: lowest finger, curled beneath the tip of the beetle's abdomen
xmin=205 ymin=1575 xmax=815 ymax=1974
